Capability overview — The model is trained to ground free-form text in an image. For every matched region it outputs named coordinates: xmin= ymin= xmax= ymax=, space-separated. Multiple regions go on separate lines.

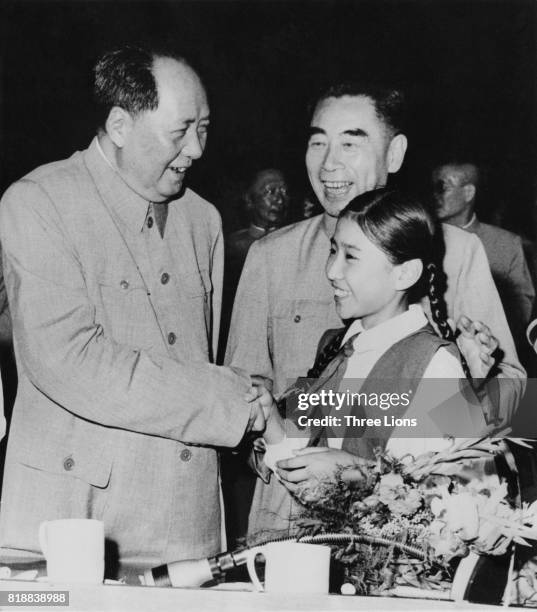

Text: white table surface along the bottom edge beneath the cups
xmin=0 ymin=580 xmax=500 ymax=612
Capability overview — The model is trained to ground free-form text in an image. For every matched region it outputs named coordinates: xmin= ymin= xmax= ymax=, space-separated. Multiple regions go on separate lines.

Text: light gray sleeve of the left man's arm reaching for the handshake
xmin=0 ymin=181 xmax=250 ymax=446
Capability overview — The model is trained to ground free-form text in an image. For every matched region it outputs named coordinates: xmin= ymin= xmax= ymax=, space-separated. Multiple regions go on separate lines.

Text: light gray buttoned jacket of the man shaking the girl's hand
xmin=0 ymin=140 xmax=249 ymax=565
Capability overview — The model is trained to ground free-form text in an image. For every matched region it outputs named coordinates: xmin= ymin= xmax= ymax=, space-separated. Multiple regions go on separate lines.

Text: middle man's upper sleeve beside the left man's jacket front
xmin=225 ymin=242 xmax=277 ymax=380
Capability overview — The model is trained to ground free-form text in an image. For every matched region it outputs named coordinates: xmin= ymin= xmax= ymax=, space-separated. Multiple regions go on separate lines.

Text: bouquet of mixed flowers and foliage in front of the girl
xmin=292 ymin=438 xmax=537 ymax=599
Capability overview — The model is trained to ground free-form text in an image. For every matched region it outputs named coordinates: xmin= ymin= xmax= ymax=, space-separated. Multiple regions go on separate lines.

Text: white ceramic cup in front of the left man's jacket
xmin=39 ymin=519 xmax=104 ymax=584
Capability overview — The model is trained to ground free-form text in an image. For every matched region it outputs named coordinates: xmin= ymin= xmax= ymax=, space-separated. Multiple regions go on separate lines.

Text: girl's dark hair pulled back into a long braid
xmin=340 ymin=188 xmax=469 ymax=376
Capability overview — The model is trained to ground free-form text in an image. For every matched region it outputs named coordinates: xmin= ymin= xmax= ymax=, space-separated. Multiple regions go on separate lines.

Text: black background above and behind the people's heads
xmin=0 ymin=0 xmax=537 ymax=234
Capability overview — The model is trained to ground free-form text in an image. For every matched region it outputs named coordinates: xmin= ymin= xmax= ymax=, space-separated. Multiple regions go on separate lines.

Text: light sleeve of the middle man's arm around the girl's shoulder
xmin=446 ymin=234 xmax=526 ymax=423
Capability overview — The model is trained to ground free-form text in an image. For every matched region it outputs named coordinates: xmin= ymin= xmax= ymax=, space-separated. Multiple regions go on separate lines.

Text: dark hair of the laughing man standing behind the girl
xmin=314 ymin=81 xmax=406 ymax=137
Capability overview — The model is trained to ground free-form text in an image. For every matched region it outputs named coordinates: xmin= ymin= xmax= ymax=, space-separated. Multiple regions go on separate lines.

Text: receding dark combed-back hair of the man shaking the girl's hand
xmin=93 ymin=45 xmax=188 ymax=128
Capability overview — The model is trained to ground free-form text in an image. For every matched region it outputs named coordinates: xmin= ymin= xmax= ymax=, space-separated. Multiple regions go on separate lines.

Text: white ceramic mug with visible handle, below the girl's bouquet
xmin=246 ymin=542 xmax=330 ymax=593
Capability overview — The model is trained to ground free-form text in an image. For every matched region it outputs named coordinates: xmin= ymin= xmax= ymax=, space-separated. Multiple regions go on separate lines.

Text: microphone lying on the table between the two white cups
xmin=144 ymin=548 xmax=249 ymax=587
